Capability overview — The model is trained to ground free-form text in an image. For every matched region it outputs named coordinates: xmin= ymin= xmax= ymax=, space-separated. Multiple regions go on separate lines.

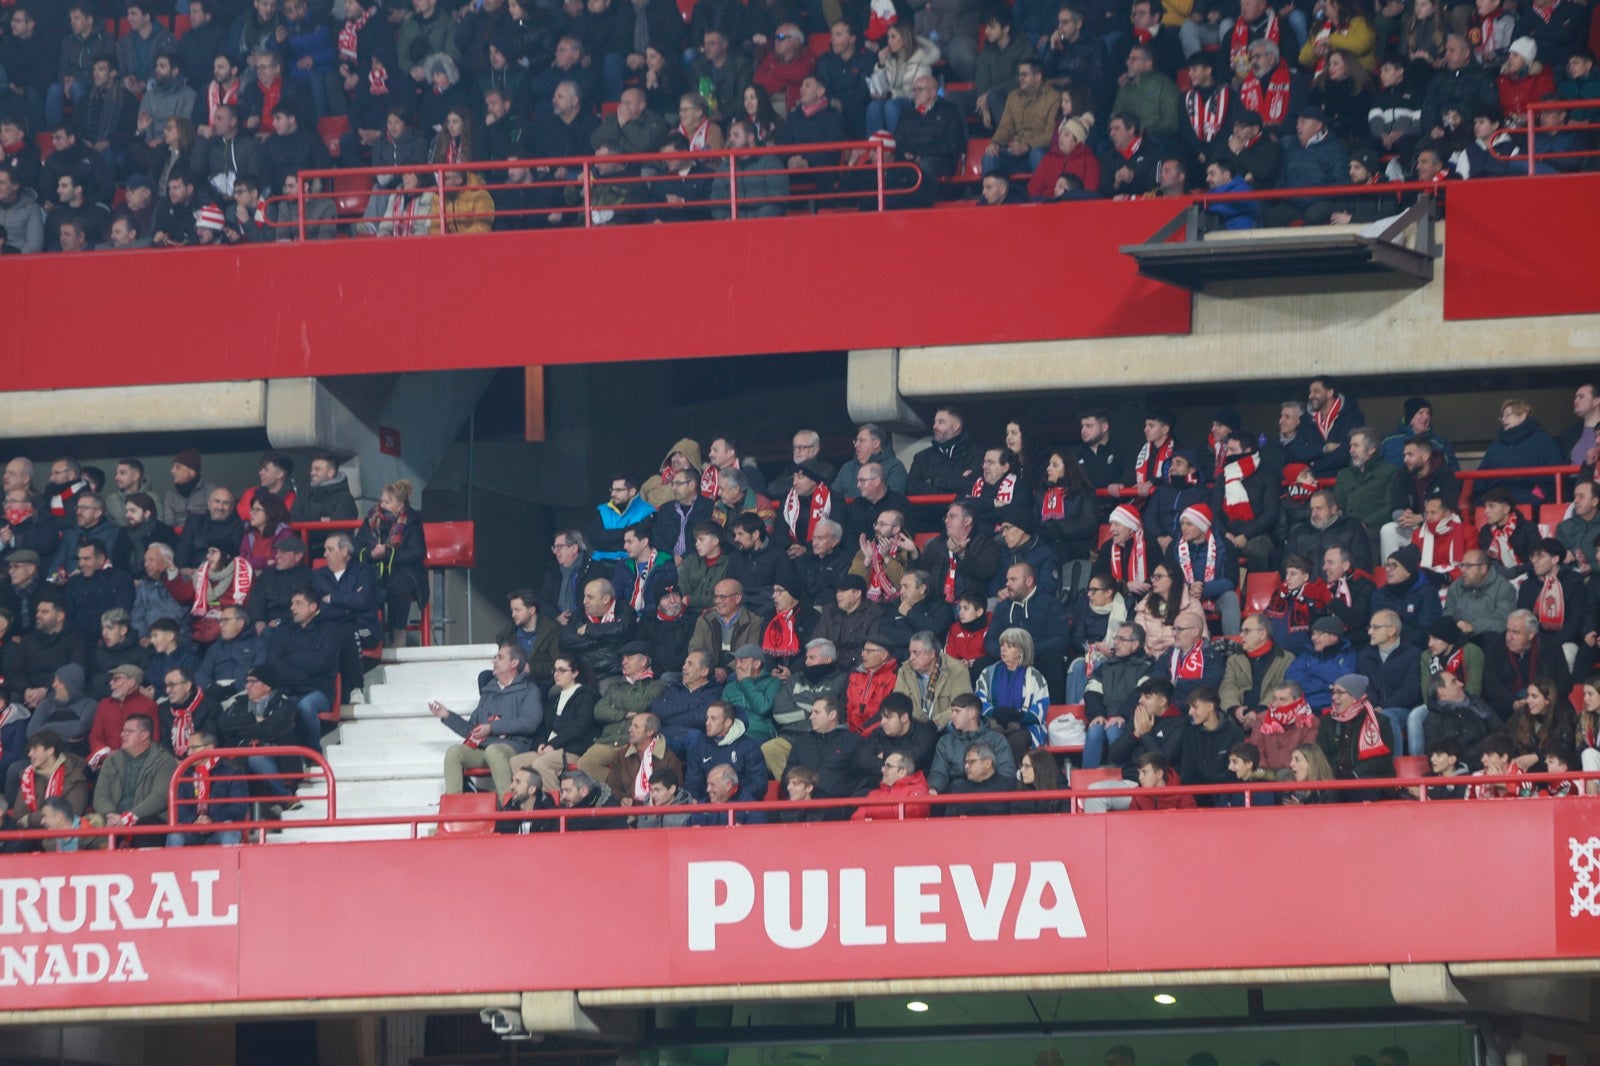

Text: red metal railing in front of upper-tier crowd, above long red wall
xmin=278 ymin=141 xmax=922 ymax=240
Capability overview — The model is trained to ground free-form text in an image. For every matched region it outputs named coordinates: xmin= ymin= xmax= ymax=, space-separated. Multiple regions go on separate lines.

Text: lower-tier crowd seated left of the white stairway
xmin=0 ymin=448 xmax=427 ymax=844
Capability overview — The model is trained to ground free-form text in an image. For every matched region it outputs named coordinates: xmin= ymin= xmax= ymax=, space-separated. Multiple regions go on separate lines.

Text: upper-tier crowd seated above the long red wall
xmin=0 ymin=0 xmax=1600 ymax=253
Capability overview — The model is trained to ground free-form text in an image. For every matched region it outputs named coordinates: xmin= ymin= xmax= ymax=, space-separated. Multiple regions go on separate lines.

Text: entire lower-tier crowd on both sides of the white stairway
xmin=0 ymin=378 xmax=1600 ymax=837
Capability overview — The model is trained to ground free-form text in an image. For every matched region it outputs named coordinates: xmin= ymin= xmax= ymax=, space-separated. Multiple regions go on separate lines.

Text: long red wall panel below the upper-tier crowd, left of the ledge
xmin=0 ymin=202 xmax=1190 ymax=389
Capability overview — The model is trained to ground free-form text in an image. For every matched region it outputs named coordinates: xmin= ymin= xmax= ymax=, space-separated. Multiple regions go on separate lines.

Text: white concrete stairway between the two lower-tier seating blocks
xmin=267 ymin=643 xmax=494 ymax=844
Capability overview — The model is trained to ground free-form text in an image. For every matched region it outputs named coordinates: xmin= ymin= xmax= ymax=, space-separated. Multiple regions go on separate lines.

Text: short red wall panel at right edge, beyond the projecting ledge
xmin=1445 ymin=174 xmax=1600 ymax=319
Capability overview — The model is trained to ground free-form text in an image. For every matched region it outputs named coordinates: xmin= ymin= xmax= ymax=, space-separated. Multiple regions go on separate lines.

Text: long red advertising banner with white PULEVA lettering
xmin=0 ymin=799 xmax=1600 ymax=1010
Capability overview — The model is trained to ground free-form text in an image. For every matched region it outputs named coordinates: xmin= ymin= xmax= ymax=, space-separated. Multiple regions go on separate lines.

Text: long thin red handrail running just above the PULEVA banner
xmin=0 ymin=768 xmax=1600 ymax=842
